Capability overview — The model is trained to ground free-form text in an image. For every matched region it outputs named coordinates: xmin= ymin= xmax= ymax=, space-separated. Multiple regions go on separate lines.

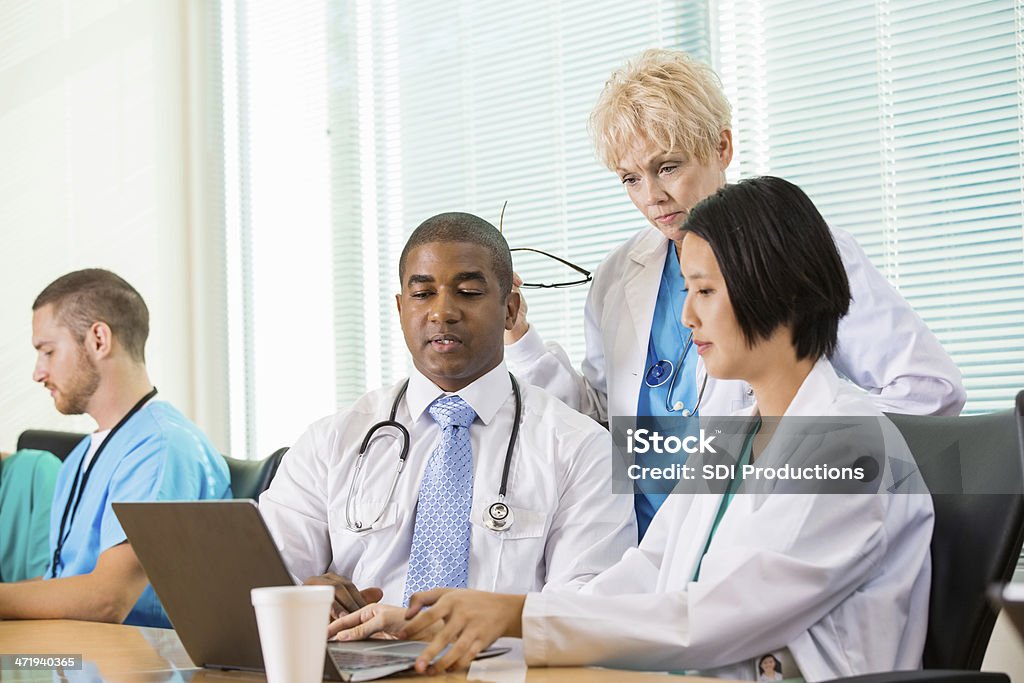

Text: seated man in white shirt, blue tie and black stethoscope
xmin=260 ymin=213 xmax=637 ymax=609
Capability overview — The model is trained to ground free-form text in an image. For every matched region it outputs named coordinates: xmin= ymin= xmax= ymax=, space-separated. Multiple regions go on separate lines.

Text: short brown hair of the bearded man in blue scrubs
xmin=32 ymin=268 xmax=150 ymax=362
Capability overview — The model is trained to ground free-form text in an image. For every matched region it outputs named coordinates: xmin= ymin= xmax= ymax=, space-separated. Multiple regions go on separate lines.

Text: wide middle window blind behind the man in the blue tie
xmin=331 ymin=0 xmax=696 ymax=397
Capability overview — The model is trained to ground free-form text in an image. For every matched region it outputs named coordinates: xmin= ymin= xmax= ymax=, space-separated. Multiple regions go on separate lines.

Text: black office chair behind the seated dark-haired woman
xmin=823 ymin=391 xmax=1024 ymax=683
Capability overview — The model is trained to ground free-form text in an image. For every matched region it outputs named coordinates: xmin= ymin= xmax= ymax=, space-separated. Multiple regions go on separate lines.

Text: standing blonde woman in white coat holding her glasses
xmin=505 ymin=50 xmax=965 ymax=537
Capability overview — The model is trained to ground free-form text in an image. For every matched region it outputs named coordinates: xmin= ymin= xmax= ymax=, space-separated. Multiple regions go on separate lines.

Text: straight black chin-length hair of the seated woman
xmin=683 ymin=176 xmax=850 ymax=359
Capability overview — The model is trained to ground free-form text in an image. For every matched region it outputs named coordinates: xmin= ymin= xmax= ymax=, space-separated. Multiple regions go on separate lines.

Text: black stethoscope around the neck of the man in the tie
xmin=345 ymin=373 xmax=522 ymax=533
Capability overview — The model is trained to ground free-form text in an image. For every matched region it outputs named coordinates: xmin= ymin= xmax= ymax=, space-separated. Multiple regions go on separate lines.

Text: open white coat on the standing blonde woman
xmin=505 ymin=227 xmax=966 ymax=422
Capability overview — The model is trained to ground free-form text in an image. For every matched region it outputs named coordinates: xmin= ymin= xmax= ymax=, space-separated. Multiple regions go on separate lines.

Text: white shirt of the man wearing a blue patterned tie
xmin=260 ymin=362 xmax=637 ymax=604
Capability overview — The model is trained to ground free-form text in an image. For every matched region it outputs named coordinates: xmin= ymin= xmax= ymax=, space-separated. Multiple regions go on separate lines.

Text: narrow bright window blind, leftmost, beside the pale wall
xmin=218 ymin=0 xmax=335 ymax=458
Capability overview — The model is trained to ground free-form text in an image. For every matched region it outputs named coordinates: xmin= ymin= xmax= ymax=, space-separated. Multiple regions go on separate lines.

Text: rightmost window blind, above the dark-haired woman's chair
xmin=715 ymin=0 xmax=1024 ymax=577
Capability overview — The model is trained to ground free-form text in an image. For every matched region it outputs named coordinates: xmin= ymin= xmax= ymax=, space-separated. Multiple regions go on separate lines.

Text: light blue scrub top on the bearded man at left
xmin=44 ymin=401 xmax=231 ymax=628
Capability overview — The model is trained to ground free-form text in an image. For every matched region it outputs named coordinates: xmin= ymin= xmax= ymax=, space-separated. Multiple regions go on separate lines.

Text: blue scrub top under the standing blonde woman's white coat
xmin=635 ymin=242 xmax=697 ymax=539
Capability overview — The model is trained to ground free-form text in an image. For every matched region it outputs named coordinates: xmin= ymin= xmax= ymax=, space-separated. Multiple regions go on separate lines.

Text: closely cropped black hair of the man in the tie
xmin=398 ymin=212 xmax=512 ymax=296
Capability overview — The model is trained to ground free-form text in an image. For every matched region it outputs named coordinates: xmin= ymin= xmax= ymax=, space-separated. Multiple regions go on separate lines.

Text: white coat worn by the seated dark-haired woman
xmin=522 ymin=361 xmax=933 ymax=681
